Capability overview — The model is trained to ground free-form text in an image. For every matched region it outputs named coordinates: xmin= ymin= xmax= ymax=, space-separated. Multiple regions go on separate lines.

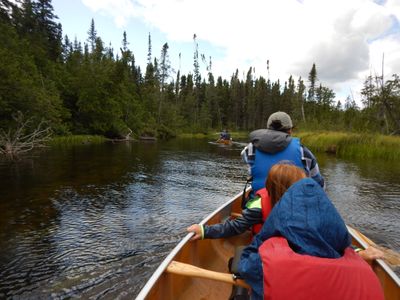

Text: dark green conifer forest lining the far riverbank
xmin=0 ymin=0 xmax=400 ymax=137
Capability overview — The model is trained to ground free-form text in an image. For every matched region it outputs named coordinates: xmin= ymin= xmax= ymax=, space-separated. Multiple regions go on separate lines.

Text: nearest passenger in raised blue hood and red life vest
xmin=238 ymin=178 xmax=383 ymax=300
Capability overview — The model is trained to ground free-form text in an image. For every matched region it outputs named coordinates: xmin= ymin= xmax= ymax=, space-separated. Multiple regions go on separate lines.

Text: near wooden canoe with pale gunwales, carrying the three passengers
xmin=137 ymin=190 xmax=400 ymax=300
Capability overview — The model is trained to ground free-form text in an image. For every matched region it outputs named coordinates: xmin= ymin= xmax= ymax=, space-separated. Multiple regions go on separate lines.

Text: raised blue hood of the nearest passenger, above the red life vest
xmin=264 ymin=178 xmax=351 ymax=258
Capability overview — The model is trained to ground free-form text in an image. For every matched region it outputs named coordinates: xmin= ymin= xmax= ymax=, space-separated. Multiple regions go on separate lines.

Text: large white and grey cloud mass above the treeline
xmin=82 ymin=0 xmax=400 ymax=101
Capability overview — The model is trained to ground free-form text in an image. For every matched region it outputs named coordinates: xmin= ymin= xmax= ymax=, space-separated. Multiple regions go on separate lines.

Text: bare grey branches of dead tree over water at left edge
xmin=0 ymin=112 xmax=52 ymax=160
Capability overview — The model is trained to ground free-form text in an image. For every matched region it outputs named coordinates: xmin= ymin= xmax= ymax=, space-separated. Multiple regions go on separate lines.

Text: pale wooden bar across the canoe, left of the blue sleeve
xmin=167 ymin=261 xmax=250 ymax=289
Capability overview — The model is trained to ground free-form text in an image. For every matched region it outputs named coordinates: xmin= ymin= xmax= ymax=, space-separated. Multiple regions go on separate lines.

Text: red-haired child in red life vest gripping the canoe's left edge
xmin=187 ymin=161 xmax=306 ymax=241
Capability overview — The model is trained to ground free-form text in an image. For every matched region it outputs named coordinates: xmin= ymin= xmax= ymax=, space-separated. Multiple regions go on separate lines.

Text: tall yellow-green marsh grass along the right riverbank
xmin=294 ymin=132 xmax=400 ymax=160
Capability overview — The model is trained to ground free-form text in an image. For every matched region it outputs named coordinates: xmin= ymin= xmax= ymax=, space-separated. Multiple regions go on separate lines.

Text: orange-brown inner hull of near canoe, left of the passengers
xmin=146 ymin=194 xmax=251 ymax=300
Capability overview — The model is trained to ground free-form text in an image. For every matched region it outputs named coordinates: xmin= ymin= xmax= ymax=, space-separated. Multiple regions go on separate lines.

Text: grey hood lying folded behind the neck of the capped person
xmin=250 ymin=129 xmax=292 ymax=154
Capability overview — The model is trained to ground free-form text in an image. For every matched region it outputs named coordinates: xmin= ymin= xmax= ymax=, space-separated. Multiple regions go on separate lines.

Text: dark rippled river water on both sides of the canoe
xmin=0 ymin=139 xmax=400 ymax=299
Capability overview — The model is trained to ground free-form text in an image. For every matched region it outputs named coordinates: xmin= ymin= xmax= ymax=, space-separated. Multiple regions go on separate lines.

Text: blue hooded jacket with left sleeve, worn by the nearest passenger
xmin=239 ymin=178 xmax=351 ymax=299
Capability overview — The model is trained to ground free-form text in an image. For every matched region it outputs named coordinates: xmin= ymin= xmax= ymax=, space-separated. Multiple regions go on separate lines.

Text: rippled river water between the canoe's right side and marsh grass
xmin=324 ymin=159 xmax=400 ymax=251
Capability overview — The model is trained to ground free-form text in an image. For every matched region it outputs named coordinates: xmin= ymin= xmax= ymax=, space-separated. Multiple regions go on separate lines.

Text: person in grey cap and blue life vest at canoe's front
xmin=241 ymin=111 xmax=325 ymax=191
